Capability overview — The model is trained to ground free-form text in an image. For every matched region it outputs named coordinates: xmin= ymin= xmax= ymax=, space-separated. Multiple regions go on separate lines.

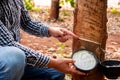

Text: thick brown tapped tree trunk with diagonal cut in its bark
xmin=73 ymin=0 xmax=107 ymax=80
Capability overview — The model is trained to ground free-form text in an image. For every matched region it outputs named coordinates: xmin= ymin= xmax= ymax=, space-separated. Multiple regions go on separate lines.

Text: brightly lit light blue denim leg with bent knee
xmin=0 ymin=47 xmax=26 ymax=80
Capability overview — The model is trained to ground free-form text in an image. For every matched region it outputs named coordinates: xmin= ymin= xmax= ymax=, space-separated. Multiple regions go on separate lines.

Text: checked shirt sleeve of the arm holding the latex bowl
xmin=0 ymin=21 xmax=50 ymax=67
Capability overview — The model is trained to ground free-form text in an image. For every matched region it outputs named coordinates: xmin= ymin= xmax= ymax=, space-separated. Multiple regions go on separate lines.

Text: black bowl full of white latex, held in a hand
xmin=72 ymin=49 xmax=98 ymax=72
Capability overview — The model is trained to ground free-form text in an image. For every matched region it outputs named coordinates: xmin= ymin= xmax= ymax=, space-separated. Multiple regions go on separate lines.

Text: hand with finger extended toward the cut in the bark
xmin=48 ymin=27 xmax=78 ymax=42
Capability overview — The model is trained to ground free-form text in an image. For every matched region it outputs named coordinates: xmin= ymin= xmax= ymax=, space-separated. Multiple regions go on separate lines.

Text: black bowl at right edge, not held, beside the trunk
xmin=100 ymin=60 xmax=120 ymax=79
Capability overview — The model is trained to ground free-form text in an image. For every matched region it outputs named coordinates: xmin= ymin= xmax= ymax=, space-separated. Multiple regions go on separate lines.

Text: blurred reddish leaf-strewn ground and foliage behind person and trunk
xmin=21 ymin=0 xmax=120 ymax=80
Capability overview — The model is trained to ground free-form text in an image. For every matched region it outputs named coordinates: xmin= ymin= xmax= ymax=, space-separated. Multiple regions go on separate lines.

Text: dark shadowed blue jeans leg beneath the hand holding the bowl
xmin=21 ymin=66 xmax=65 ymax=80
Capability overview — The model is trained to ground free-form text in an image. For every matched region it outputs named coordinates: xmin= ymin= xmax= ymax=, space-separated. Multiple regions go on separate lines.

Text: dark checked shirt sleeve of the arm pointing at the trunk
xmin=20 ymin=0 xmax=50 ymax=37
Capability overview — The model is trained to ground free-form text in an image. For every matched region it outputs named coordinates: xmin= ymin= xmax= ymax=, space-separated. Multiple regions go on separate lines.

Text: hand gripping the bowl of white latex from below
xmin=47 ymin=58 xmax=85 ymax=75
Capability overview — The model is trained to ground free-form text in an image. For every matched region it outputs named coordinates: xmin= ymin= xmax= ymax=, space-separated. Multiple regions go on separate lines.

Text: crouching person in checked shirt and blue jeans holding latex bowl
xmin=0 ymin=0 xmax=84 ymax=80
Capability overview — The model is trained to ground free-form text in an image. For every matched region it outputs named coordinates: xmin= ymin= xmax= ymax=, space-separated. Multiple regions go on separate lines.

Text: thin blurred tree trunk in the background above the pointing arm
xmin=50 ymin=0 xmax=60 ymax=20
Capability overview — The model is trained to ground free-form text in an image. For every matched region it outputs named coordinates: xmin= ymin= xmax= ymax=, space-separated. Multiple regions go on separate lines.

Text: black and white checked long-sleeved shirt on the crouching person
xmin=0 ymin=0 xmax=50 ymax=67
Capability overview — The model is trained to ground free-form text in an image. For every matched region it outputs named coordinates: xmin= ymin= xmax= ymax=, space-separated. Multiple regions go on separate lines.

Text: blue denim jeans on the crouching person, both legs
xmin=0 ymin=47 xmax=65 ymax=80
